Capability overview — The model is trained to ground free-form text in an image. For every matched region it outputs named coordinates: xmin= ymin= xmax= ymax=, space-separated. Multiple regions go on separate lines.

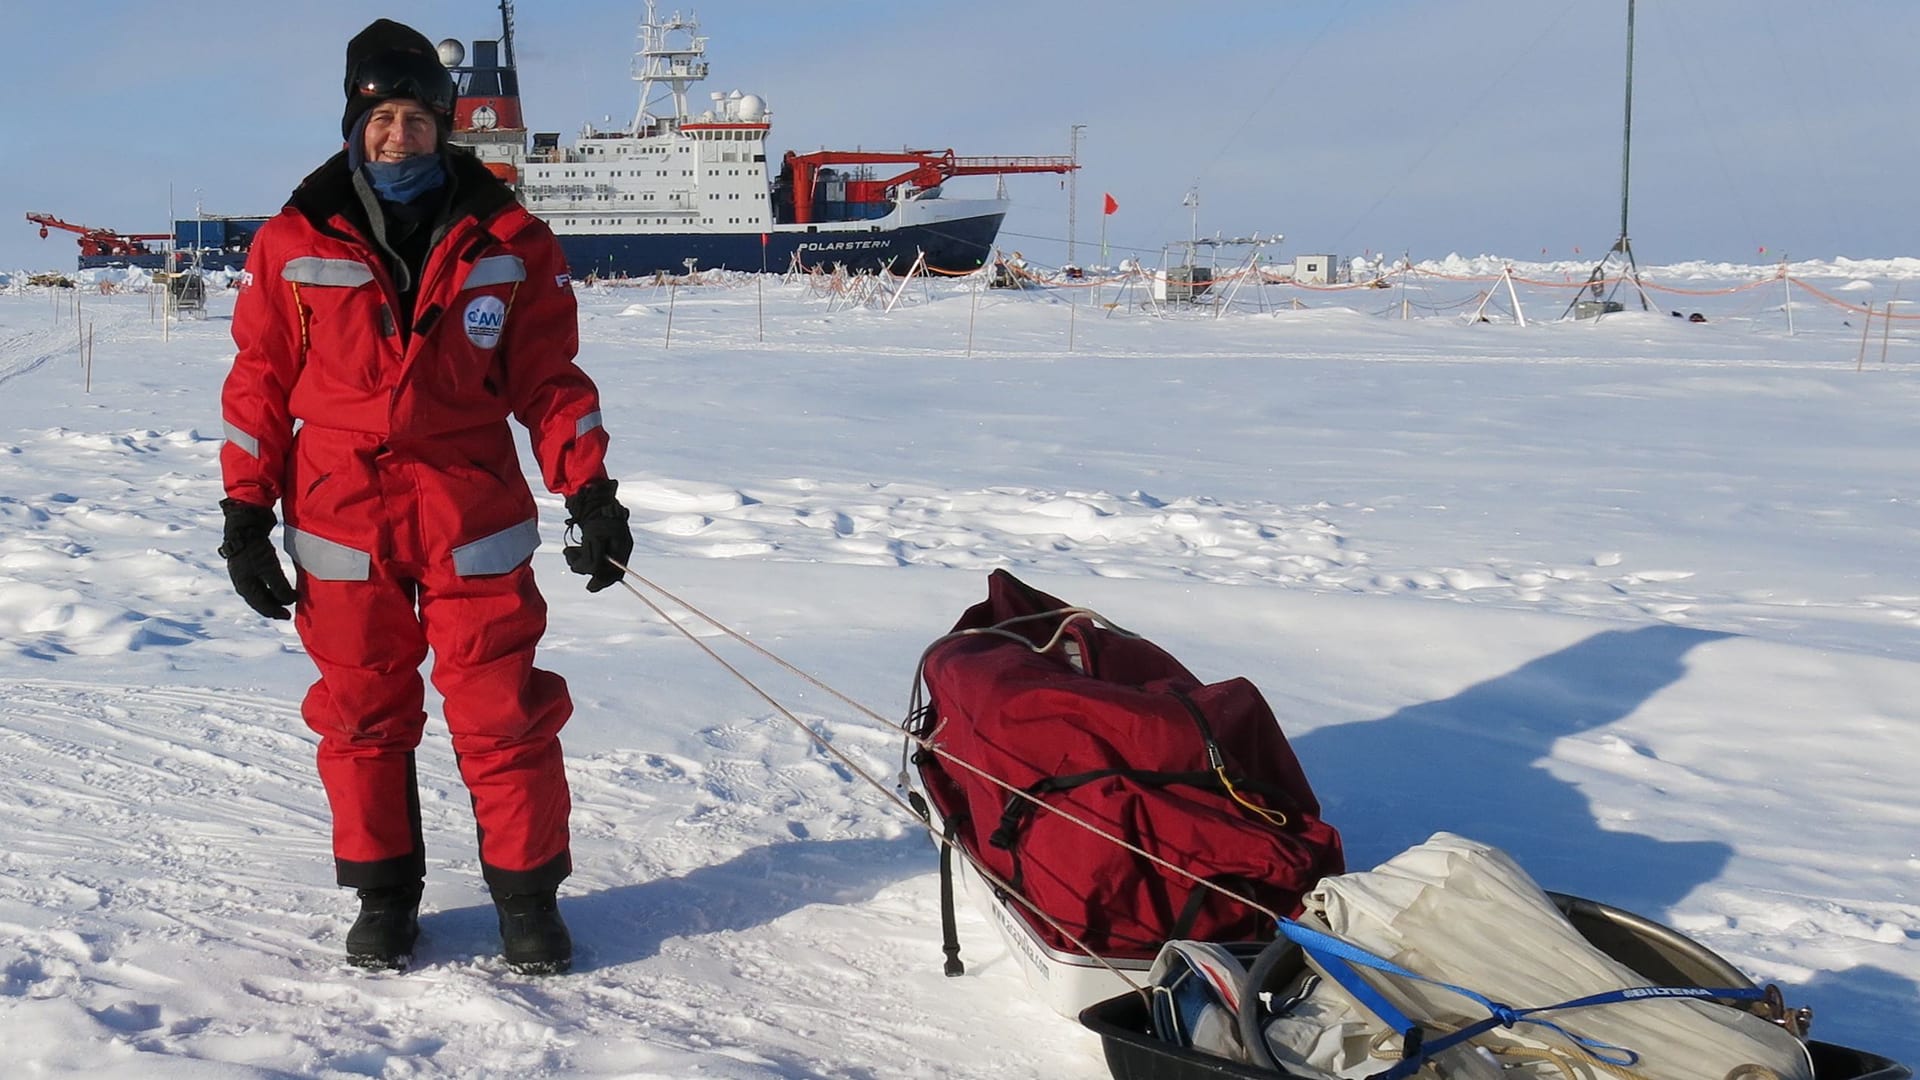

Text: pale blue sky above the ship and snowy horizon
xmin=0 ymin=0 xmax=1920 ymax=267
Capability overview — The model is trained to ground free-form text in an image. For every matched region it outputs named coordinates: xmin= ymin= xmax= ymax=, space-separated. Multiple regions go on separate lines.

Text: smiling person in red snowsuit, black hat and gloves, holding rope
xmin=221 ymin=19 xmax=634 ymax=972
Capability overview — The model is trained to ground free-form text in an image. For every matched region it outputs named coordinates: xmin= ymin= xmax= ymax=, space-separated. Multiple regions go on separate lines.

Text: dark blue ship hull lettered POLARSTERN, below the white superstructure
xmin=559 ymin=213 xmax=1004 ymax=279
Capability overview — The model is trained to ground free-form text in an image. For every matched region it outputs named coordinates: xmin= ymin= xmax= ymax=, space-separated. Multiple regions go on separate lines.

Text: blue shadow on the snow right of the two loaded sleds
xmin=1292 ymin=625 xmax=1920 ymax=1061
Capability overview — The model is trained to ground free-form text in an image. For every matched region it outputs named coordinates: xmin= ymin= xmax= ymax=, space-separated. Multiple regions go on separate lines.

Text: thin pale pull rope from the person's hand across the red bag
xmin=607 ymin=557 xmax=1284 ymax=960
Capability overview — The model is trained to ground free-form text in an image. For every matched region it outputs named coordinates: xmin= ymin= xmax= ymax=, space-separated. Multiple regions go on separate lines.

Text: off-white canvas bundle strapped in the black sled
xmin=1267 ymin=832 xmax=1812 ymax=1080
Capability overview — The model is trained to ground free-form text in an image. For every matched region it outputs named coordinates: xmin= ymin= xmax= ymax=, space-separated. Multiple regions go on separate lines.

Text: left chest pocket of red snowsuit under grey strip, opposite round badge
xmin=280 ymin=256 xmax=392 ymax=390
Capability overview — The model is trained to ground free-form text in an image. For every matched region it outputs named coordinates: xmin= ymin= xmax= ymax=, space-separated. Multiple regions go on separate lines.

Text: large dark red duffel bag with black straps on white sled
xmin=908 ymin=571 xmax=1344 ymax=974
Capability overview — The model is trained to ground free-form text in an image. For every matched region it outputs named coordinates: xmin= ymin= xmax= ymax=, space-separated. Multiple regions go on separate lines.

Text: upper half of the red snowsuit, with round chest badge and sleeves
xmin=221 ymin=152 xmax=607 ymax=577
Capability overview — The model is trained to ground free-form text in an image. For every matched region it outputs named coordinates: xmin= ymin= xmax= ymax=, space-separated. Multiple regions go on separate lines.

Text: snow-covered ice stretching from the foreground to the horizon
xmin=0 ymin=259 xmax=1920 ymax=1080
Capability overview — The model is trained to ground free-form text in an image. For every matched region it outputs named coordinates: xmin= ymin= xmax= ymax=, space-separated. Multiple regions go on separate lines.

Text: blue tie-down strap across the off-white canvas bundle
xmin=1281 ymin=919 xmax=1766 ymax=1080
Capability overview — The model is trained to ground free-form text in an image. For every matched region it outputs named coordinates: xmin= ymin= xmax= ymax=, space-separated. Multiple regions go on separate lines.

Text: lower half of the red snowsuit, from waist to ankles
xmin=286 ymin=425 xmax=572 ymax=894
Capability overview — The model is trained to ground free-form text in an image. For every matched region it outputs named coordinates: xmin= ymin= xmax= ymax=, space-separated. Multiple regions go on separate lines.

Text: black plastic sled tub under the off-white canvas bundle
xmin=1079 ymin=894 xmax=1912 ymax=1080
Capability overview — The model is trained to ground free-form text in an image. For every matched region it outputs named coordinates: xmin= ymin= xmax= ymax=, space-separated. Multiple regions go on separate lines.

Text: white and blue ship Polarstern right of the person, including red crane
xmin=440 ymin=0 xmax=1077 ymax=279
